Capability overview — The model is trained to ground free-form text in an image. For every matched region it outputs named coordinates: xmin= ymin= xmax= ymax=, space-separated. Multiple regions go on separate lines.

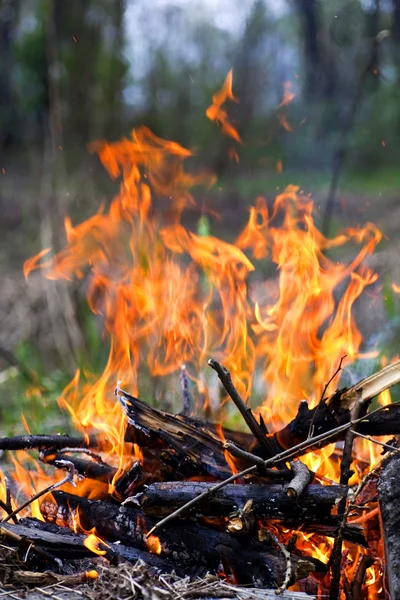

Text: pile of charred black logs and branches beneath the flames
xmin=0 ymin=360 xmax=400 ymax=600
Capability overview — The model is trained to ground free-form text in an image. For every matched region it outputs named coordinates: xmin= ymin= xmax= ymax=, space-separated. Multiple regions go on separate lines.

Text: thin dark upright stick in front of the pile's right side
xmin=329 ymin=394 xmax=364 ymax=600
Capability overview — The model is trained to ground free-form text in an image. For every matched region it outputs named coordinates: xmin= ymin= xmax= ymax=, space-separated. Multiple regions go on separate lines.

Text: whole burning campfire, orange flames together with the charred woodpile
xmin=0 ymin=73 xmax=400 ymax=600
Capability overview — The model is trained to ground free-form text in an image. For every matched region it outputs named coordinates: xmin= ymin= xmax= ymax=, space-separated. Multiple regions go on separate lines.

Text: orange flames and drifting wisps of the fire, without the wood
xmin=15 ymin=71 xmax=390 ymax=592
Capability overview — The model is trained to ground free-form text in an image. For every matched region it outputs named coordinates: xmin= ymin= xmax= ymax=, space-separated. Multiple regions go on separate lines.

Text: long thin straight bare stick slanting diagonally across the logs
xmin=146 ymin=402 xmax=394 ymax=538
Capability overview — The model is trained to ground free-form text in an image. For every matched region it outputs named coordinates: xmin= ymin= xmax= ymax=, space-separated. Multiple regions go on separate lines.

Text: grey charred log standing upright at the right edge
xmin=378 ymin=454 xmax=400 ymax=600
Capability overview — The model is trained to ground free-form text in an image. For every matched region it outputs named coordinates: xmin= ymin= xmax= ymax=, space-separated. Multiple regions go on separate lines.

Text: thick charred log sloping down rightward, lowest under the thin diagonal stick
xmin=41 ymin=491 xmax=326 ymax=588
